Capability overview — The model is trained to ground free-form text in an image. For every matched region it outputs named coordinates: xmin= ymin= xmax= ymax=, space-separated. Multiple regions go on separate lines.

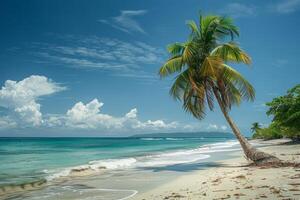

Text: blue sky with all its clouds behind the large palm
xmin=0 ymin=0 xmax=300 ymax=136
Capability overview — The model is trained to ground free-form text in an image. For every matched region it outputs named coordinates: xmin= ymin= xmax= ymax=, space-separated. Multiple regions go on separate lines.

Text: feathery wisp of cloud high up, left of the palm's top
xmin=99 ymin=10 xmax=147 ymax=33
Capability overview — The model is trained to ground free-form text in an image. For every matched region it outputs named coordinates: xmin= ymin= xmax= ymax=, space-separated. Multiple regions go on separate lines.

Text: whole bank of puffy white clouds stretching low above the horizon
xmin=0 ymin=75 xmax=227 ymax=133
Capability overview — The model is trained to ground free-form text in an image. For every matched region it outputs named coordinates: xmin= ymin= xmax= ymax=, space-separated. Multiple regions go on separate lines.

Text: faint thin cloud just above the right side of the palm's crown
xmin=221 ymin=3 xmax=255 ymax=18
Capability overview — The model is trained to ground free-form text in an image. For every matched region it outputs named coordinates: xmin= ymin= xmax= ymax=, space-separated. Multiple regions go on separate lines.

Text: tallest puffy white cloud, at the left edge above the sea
xmin=0 ymin=75 xmax=65 ymax=126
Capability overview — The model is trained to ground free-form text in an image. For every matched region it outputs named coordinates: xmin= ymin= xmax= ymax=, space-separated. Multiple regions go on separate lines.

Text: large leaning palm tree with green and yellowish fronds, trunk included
xmin=159 ymin=15 xmax=279 ymax=164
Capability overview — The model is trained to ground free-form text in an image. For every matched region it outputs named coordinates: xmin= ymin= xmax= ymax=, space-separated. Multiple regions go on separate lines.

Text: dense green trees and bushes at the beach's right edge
xmin=251 ymin=84 xmax=300 ymax=140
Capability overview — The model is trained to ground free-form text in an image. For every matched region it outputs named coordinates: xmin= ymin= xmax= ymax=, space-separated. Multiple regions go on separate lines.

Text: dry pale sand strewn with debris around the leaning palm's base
xmin=133 ymin=140 xmax=300 ymax=200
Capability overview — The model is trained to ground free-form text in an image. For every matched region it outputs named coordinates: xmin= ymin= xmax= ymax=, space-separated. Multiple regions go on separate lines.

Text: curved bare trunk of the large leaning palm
xmin=214 ymin=89 xmax=280 ymax=164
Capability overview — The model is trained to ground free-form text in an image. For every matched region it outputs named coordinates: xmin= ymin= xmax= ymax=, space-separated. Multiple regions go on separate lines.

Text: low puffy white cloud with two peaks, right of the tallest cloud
xmin=61 ymin=99 xmax=177 ymax=131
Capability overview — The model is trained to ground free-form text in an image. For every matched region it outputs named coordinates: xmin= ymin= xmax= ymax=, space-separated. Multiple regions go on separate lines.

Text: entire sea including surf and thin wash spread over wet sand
xmin=0 ymin=137 xmax=238 ymax=199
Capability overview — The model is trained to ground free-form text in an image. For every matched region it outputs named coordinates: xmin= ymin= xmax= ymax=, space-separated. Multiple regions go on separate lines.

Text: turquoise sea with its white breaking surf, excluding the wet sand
xmin=0 ymin=137 xmax=235 ymax=186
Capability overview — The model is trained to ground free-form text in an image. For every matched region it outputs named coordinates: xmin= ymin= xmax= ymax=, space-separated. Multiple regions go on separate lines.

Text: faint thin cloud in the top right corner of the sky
xmin=272 ymin=0 xmax=300 ymax=14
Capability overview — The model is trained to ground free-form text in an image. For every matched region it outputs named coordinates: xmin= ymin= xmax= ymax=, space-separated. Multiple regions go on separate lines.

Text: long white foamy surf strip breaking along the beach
xmin=44 ymin=140 xmax=239 ymax=181
